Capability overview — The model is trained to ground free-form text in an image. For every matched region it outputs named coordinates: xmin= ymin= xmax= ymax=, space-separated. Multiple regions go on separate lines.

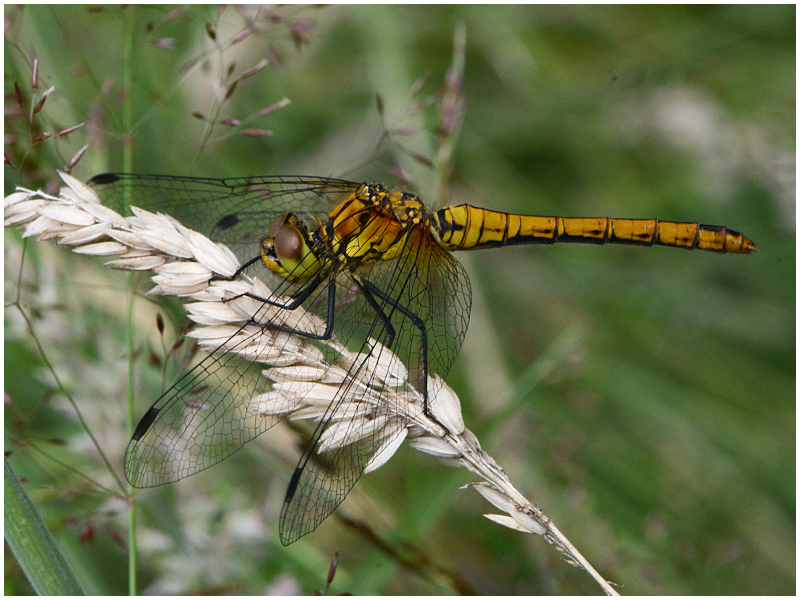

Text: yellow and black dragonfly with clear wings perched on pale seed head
xmin=88 ymin=174 xmax=758 ymax=545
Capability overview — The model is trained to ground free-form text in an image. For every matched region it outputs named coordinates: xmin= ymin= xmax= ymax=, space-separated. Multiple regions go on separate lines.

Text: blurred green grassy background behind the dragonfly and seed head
xmin=4 ymin=5 xmax=795 ymax=595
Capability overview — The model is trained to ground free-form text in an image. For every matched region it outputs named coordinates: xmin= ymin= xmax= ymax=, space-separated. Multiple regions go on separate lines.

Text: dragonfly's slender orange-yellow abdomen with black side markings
xmin=436 ymin=204 xmax=758 ymax=254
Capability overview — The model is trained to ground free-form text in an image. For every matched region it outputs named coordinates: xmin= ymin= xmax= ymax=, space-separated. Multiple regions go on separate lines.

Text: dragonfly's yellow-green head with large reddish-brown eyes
xmin=261 ymin=213 xmax=321 ymax=284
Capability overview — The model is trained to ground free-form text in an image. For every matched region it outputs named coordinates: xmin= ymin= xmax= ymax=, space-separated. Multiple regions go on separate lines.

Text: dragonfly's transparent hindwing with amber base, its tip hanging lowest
xmin=280 ymin=225 xmax=471 ymax=545
